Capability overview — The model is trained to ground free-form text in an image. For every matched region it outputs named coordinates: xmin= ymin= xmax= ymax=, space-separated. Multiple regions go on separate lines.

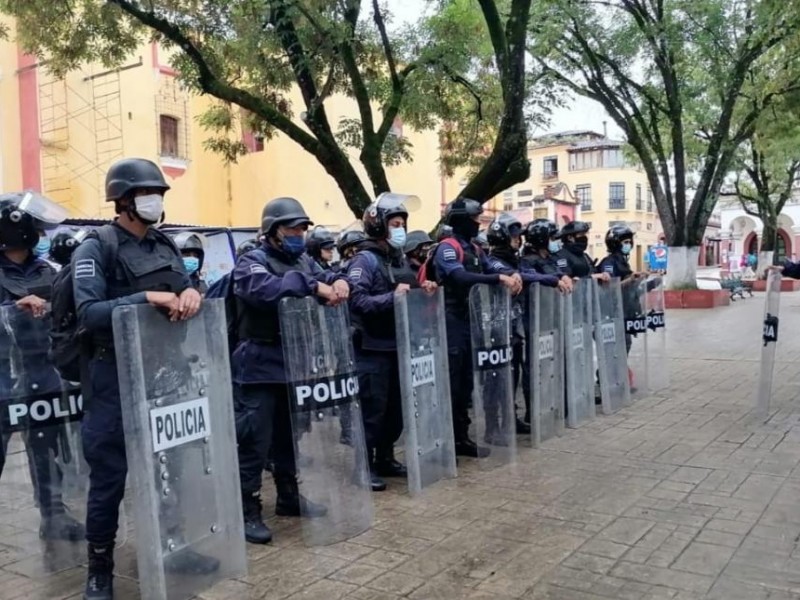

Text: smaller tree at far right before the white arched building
xmin=734 ymin=96 xmax=800 ymax=272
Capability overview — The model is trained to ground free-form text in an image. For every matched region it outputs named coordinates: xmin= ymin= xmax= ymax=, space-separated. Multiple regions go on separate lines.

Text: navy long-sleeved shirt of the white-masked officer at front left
xmin=72 ymin=224 xmax=192 ymax=331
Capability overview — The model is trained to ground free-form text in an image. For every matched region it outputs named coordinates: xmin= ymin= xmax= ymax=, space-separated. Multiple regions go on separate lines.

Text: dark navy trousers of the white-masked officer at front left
xmin=81 ymin=357 xmax=128 ymax=545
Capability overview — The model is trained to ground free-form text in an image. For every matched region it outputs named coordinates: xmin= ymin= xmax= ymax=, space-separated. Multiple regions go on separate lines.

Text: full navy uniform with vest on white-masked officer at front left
xmin=72 ymin=223 xmax=192 ymax=545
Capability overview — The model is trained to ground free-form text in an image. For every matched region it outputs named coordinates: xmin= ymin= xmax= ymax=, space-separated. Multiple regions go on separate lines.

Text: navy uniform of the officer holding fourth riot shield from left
xmin=347 ymin=242 xmax=418 ymax=462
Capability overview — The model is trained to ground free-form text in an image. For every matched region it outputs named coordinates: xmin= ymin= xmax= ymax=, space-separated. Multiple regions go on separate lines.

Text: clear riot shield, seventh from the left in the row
xmin=564 ymin=279 xmax=595 ymax=427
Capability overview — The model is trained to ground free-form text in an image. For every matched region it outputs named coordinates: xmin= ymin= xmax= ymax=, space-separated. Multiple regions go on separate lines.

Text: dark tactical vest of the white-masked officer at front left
xmin=92 ymin=227 xmax=186 ymax=348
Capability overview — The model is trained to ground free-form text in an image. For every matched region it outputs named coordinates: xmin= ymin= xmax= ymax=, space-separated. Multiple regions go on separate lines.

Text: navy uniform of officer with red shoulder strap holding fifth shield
xmin=433 ymin=237 xmax=500 ymax=443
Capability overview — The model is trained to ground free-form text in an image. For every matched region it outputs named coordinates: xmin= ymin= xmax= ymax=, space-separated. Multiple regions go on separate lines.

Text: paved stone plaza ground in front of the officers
xmin=0 ymin=294 xmax=800 ymax=600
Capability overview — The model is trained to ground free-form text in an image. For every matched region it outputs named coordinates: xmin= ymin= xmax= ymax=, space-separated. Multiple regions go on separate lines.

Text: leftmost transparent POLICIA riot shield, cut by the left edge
xmin=0 ymin=305 xmax=88 ymax=580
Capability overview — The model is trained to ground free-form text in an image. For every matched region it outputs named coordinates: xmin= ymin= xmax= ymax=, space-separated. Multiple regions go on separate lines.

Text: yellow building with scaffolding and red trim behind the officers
xmin=0 ymin=37 xmax=451 ymax=230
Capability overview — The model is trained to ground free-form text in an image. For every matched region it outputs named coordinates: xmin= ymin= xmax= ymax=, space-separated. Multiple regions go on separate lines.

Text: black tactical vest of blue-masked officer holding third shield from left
xmin=236 ymin=249 xmax=314 ymax=345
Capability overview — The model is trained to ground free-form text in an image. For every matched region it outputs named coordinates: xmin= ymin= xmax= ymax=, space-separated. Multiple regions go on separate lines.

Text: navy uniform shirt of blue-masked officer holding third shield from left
xmin=231 ymin=244 xmax=344 ymax=384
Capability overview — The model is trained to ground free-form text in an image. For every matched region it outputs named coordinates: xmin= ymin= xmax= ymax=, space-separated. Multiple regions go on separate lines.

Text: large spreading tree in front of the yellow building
xmin=0 ymin=0 xmax=531 ymax=217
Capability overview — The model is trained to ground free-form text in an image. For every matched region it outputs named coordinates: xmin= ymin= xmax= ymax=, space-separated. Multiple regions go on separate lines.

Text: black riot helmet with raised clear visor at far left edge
xmin=0 ymin=192 xmax=67 ymax=250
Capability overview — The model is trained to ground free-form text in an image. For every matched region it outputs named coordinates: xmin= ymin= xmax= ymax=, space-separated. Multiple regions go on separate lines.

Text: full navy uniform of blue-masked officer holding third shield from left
xmin=231 ymin=244 xmax=341 ymax=497
